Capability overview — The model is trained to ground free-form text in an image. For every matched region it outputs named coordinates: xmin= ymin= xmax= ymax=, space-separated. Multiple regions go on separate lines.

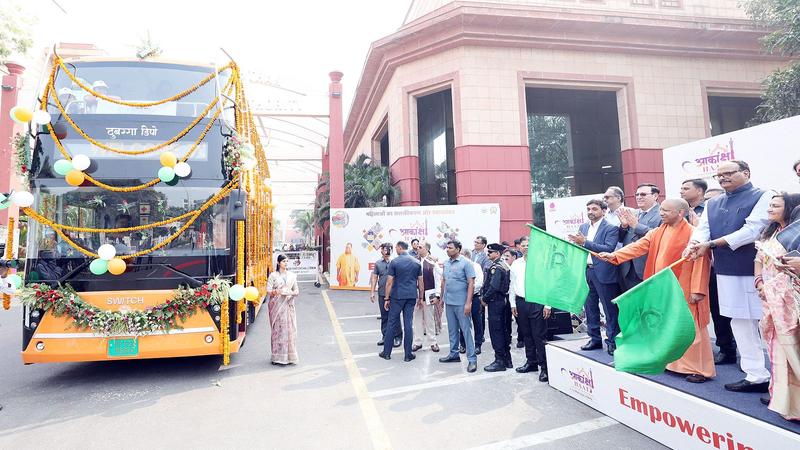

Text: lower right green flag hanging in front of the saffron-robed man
xmin=614 ymin=267 xmax=695 ymax=374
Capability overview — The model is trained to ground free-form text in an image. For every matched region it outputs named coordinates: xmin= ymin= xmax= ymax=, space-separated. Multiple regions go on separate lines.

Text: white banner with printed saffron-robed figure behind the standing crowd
xmin=330 ymin=203 xmax=500 ymax=289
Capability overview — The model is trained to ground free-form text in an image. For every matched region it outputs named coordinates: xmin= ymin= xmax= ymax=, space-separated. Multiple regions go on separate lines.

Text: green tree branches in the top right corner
xmin=745 ymin=0 xmax=800 ymax=124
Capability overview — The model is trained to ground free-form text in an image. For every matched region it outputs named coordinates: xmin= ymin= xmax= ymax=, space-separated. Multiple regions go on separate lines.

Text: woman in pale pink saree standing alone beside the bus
xmin=267 ymin=255 xmax=300 ymax=365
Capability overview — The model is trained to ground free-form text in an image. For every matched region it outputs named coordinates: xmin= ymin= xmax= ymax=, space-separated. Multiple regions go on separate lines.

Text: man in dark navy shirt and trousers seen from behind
xmin=378 ymin=241 xmax=424 ymax=362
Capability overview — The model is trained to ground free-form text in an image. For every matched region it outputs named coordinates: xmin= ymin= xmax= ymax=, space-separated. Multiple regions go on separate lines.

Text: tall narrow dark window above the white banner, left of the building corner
xmin=417 ymin=89 xmax=457 ymax=205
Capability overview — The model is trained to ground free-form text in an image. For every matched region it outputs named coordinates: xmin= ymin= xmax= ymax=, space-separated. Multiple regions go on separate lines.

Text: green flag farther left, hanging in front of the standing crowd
xmin=525 ymin=225 xmax=589 ymax=314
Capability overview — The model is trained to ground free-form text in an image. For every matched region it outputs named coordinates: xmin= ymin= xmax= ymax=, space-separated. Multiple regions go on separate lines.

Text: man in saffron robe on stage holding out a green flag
xmin=600 ymin=199 xmax=716 ymax=383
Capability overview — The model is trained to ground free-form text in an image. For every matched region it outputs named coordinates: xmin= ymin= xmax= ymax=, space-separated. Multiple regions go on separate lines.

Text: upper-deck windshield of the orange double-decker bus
xmin=49 ymin=61 xmax=230 ymax=117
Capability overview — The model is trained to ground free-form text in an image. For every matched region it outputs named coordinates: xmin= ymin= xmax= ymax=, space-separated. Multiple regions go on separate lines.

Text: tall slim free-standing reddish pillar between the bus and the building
xmin=328 ymin=72 xmax=344 ymax=208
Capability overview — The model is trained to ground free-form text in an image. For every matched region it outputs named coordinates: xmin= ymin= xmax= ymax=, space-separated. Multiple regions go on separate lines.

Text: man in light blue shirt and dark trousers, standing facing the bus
xmin=439 ymin=240 xmax=478 ymax=372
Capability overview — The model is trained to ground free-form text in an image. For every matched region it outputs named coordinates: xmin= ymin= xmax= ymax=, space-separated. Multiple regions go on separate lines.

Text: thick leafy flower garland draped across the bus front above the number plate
xmin=16 ymin=276 xmax=231 ymax=336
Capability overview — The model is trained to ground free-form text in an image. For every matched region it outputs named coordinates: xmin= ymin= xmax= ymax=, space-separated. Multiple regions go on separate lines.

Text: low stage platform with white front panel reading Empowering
xmin=547 ymin=335 xmax=800 ymax=450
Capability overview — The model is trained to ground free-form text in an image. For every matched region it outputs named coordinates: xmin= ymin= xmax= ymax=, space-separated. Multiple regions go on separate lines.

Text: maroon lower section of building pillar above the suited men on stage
xmin=622 ymin=148 xmax=664 ymax=208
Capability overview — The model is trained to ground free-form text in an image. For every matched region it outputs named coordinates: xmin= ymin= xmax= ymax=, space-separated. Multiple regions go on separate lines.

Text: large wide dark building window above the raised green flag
xmin=525 ymin=88 xmax=623 ymax=228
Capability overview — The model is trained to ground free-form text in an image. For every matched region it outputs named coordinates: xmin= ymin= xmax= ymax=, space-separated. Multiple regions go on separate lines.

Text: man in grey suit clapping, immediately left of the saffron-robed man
xmin=619 ymin=183 xmax=661 ymax=290
